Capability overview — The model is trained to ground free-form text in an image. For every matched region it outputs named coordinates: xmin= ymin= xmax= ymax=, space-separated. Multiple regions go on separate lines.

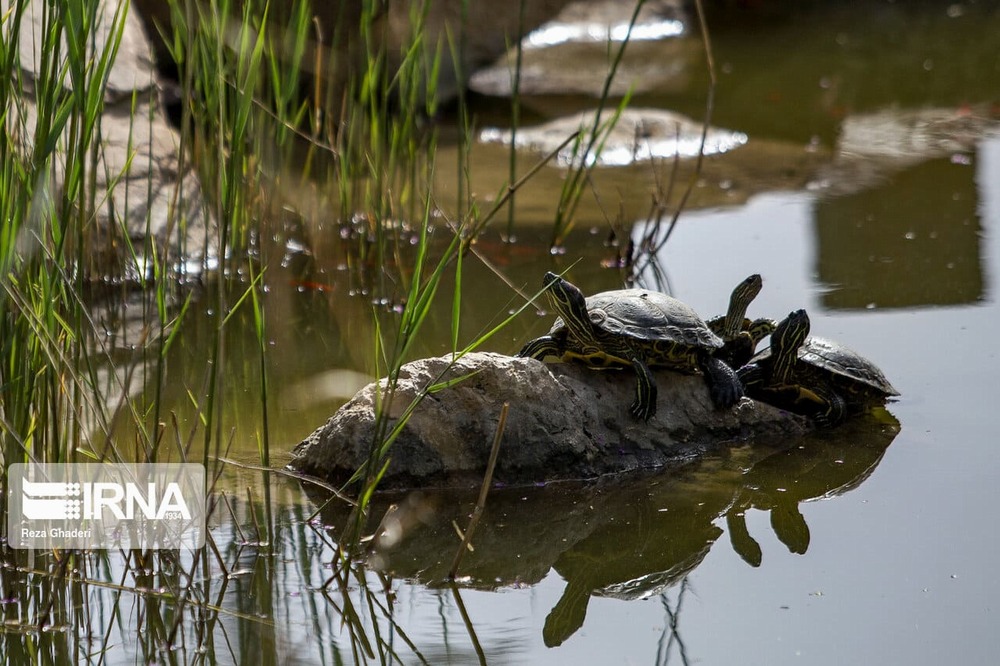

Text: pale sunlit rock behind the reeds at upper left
xmin=11 ymin=0 xmax=214 ymax=274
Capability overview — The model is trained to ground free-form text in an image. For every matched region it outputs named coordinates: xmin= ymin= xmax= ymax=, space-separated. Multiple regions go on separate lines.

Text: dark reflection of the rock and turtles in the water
xmin=312 ymin=409 xmax=899 ymax=646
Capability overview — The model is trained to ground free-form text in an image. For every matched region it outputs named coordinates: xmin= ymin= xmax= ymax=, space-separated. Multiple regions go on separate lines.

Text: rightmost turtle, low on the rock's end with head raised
xmin=737 ymin=310 xmax=899 ymax=427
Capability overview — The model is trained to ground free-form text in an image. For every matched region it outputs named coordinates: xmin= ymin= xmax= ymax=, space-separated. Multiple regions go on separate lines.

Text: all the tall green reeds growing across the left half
xmin=0 ymin=0 xmax=696 ymax=663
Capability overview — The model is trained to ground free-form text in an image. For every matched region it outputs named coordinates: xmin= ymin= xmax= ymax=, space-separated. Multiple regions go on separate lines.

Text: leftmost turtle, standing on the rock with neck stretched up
xmin=517 ymin=272 xmax=743 ymax=421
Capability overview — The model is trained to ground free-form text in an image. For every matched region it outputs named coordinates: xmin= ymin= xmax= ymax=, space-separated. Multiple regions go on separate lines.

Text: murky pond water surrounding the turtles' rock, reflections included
xmin=3 ymin=3 xmax=1000 ymax=664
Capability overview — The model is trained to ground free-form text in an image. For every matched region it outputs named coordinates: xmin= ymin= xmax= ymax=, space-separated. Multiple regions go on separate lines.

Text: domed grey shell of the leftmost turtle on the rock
xmin=550 ymin=289 xmax=724 ymax=350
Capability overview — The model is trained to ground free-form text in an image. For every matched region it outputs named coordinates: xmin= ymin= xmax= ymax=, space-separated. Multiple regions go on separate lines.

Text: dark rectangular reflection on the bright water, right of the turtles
xmin=814 ymin=157 xmax=984 ymax=310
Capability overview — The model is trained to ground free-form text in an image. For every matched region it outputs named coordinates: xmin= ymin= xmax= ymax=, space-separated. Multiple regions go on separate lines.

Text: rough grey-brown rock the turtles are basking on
xmin=290 ymin=353 xmax=809 ymax=488
